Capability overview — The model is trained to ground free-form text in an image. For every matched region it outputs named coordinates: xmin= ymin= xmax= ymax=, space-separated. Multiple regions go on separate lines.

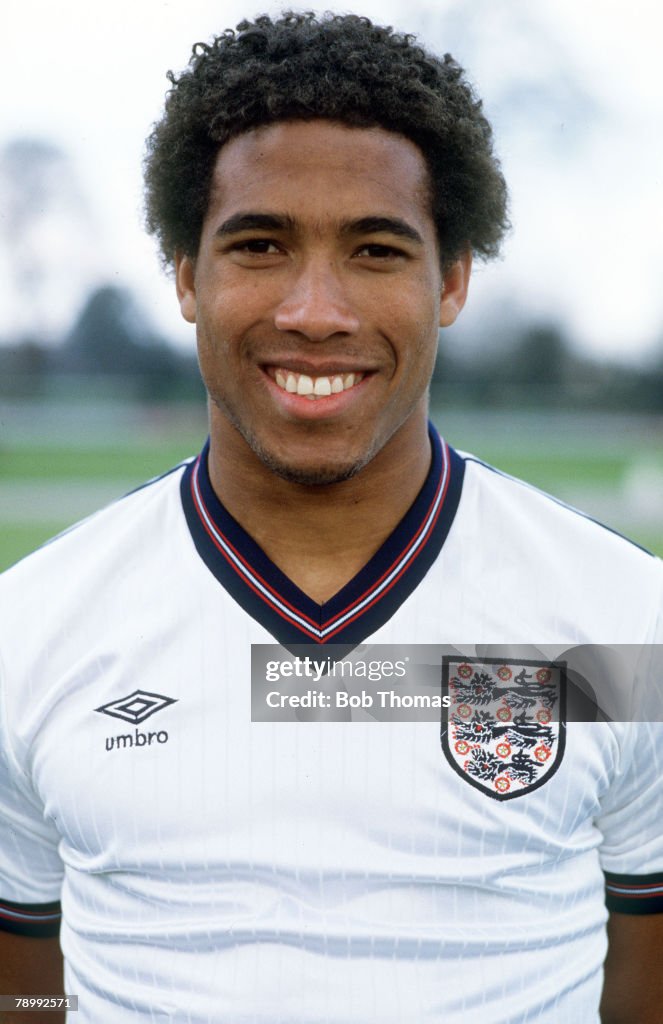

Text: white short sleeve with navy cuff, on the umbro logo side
xmin=0 ymin=655 xmax=63 ymax=937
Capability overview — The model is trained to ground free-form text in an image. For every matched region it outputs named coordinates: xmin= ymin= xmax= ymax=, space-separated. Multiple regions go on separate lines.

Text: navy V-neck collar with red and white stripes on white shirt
xmin=181 ymin=426 xmax=464 ymax=646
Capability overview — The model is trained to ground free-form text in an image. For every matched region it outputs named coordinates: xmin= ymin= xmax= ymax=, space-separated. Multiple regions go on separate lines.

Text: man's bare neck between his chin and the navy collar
xmin=209 ymin=410 xmax=430 ymax=604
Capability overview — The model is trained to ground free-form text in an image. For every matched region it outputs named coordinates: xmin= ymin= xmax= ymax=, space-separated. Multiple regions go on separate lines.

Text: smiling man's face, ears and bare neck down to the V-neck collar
xmin=175 ymin=119 xmax=471 ymax=604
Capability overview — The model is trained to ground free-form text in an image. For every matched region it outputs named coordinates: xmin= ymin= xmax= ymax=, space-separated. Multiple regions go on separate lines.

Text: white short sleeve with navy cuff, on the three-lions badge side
xmin=596 ymin=721 xmax=663 ymax=913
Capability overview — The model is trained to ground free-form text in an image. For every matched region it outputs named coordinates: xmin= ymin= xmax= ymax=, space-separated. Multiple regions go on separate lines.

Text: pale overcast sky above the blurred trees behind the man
xmin=0 ymin=0 xmax=663 ymax=356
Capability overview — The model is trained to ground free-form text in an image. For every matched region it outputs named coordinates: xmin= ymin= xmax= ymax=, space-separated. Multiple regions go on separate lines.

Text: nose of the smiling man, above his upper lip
xmin=274 ymin=258 xmax=360 ymax=341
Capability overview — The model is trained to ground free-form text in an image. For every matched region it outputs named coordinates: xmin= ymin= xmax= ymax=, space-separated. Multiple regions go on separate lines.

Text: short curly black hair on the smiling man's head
xmin=144 ymin=11 xmax=508 ymax=266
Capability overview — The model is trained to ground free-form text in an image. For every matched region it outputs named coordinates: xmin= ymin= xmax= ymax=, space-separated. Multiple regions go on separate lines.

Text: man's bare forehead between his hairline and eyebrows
xmin=208 ymin=121 xmax=434 ymax=233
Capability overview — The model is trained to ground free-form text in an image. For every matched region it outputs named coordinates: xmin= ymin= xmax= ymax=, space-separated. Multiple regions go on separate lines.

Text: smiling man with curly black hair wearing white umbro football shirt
xmin=0 ymin=14 xmax=663 ymax=1024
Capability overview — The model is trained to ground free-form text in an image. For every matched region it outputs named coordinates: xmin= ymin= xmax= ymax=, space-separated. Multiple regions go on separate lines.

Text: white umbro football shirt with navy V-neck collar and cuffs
xmin=0 ymin=428 xmax=663 ymax=1024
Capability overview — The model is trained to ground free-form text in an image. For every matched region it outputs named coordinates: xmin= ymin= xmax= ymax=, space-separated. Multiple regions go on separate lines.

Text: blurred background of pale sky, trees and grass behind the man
xmin=0 ymin=0 xmax=663 ymax=568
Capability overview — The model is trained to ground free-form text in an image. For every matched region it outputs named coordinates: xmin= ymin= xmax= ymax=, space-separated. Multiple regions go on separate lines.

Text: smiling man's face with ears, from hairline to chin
xmin=177 ymin=121 xmax=469 ymax=484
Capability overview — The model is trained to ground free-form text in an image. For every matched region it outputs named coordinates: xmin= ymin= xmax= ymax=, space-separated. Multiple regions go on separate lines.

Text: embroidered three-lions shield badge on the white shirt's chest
xmin=442 ymin=655 xmax=567 ymax=800
